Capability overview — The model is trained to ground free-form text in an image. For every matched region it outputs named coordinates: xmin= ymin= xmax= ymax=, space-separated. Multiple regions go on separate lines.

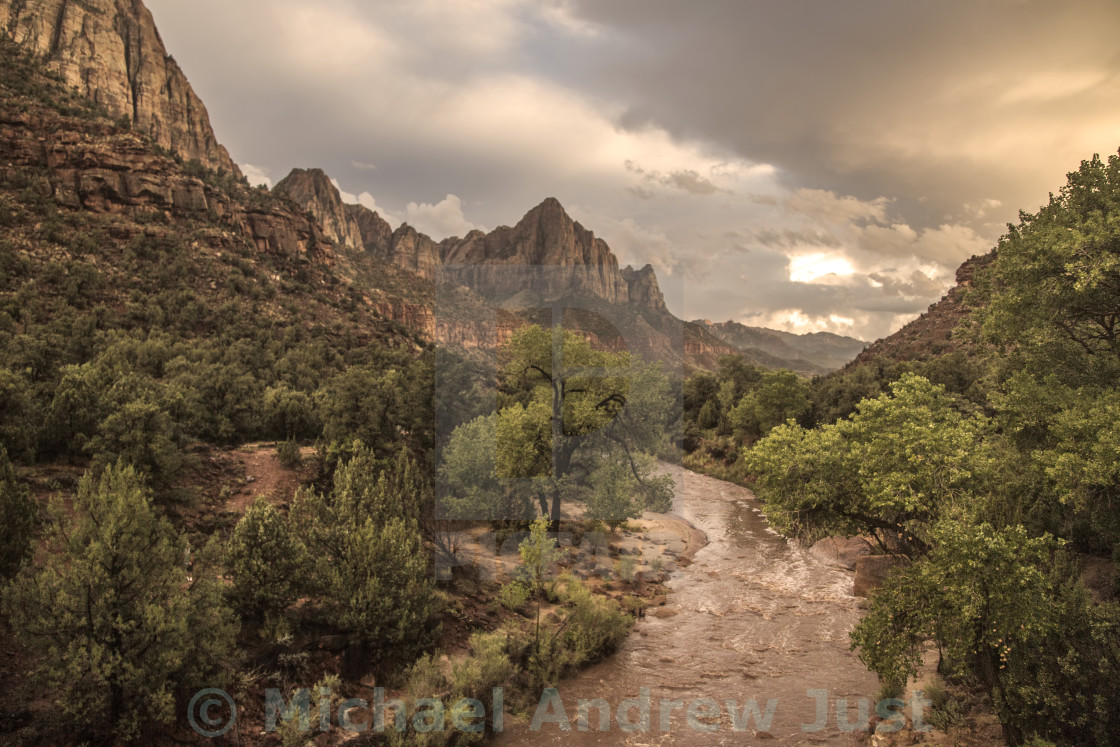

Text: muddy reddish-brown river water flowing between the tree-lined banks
xmin=494 ymin=469 xmax=878 ymax=745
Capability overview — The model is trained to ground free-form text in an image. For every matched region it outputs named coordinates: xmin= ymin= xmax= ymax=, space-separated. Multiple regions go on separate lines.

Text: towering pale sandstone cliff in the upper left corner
xmin=0 ymin=0 xmax=241 ymax=176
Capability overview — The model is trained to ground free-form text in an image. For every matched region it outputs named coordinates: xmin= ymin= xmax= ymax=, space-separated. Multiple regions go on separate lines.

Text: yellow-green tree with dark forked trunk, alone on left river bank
xmin=440 ymin=326 xmax=674 ymax=532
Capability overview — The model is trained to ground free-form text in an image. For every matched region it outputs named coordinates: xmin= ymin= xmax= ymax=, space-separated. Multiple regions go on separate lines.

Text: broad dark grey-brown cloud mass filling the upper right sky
xmin=564 ymin=0 xmax=1120 ymax=227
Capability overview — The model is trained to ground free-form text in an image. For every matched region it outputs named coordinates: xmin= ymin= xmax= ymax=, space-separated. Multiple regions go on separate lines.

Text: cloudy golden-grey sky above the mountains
xmin=147 ymin=0 xmax=1120 ymax=340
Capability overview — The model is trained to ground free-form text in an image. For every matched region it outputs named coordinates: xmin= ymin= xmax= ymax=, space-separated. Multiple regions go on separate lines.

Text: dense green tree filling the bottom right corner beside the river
xmin=852 ymin=517 xmax=1120 ymax=746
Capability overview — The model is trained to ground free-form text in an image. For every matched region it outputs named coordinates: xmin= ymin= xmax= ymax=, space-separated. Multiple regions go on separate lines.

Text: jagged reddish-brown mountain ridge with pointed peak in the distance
xmin=266 ymin=169 xmax=833 ymax=375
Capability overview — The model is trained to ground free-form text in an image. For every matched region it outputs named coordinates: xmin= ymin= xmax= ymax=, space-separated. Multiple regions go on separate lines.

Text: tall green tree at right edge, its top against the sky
xmin=972 ymin=148 xmax=1120 ymax=553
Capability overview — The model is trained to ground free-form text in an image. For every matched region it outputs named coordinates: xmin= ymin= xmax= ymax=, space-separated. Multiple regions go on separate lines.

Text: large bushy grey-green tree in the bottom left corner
xmin=4 ymin=464 xmax=235 ymax=740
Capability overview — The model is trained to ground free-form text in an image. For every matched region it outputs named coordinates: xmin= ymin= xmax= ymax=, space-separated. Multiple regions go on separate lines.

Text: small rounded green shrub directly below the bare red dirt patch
xmin=226 ymin=497 xmax=308 ymax=619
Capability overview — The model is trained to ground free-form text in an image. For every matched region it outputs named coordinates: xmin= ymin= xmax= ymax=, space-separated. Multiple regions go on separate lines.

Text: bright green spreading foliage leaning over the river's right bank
xmin=744 ymin=375 xmax=1001 ymax=552
